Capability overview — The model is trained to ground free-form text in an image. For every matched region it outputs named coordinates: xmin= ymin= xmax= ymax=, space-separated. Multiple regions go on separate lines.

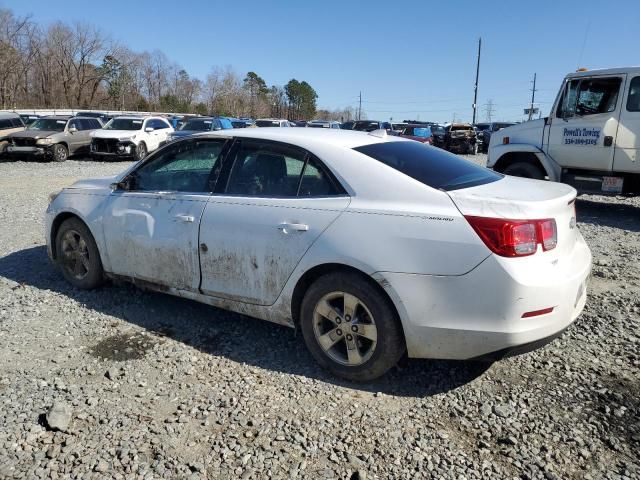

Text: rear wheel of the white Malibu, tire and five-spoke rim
xmin=300 ymin=272 xmax=406 ymax=382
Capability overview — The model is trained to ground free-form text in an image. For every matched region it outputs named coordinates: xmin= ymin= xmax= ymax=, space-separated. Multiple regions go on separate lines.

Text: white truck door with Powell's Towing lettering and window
xmin=547 ymin=74 xmax=626 ymax=171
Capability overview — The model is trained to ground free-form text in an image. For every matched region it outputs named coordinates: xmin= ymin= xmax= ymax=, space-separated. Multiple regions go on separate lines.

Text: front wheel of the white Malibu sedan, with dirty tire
xmin=56 ymin=217 xmax=104 ymax=290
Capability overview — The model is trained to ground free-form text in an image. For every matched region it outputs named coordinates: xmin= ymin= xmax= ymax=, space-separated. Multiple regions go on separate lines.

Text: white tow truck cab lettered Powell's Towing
xmin=487 ymin=67 xmax=640 ymax=194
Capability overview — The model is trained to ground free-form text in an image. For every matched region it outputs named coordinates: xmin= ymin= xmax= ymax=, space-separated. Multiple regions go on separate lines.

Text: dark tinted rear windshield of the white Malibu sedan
xmin=354 ymin=141 xmax=502 ymax=191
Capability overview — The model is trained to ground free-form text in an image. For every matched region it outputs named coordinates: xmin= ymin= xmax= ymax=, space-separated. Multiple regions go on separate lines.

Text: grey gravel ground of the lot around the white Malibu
xmin=0 ymin=156 xmax=640 ymax=479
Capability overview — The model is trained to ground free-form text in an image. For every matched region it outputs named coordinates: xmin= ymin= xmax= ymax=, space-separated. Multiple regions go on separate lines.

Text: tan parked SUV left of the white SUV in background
xmin=5 ymin=115 xmax=102 ymax=162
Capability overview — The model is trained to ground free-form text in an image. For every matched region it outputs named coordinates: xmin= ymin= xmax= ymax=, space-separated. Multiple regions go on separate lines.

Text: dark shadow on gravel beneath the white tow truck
xmin=576 ymin=197 xmax=640 ymax=232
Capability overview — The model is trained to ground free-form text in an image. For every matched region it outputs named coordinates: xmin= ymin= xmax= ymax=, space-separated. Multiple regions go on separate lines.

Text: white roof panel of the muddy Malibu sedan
xmin=198 ymin=127 xmax=411 ymax=148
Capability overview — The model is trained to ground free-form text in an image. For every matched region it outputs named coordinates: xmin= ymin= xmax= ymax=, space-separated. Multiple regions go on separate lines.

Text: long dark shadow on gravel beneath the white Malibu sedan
xmin=0 ymin=246 xmax=491 ymax=397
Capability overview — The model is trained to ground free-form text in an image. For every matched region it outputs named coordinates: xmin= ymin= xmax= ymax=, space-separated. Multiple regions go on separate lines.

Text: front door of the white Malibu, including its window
xmin=103 ymin=138 xmax=227 ymax=291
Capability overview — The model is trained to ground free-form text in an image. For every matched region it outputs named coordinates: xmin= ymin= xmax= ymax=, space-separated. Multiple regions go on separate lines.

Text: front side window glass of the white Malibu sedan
xmin=131 ymin=139 xmax=226 ymax=193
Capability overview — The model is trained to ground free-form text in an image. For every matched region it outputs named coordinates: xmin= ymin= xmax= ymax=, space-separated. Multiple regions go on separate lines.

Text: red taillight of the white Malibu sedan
xmin=465 ymin=216 xmax=558 ymax=257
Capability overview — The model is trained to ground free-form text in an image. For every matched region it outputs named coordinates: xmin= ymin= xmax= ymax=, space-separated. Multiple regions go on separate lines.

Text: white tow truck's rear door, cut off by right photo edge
xmin=613 ymin=76 xmax=640 ymax=173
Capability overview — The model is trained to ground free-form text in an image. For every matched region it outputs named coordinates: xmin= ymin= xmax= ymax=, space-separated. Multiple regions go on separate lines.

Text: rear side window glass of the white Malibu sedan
xmin=226 ymin=141 xmax=340 ymax=197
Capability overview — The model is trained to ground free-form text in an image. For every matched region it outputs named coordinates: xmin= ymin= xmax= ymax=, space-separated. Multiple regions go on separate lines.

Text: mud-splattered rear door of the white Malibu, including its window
xmin=200 ymin=138 xmax=350 ymax=305
